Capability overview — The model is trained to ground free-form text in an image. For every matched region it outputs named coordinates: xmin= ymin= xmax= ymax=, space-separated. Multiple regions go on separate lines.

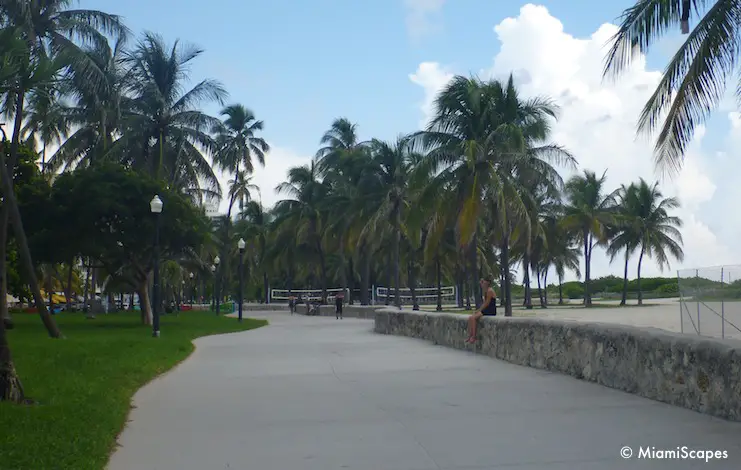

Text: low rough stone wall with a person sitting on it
xmin=374 ymin=308 xmax=741 ymax=421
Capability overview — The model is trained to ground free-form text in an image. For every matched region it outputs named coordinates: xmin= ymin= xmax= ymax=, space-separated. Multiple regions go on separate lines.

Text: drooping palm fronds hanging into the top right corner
xmin=604 ymin=0 xmax=741 ymax=173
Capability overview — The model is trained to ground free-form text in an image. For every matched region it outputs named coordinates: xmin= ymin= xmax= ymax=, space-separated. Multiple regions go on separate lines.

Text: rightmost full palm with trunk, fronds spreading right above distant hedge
xmin=628 ymin=178 xmax=684 ymax=305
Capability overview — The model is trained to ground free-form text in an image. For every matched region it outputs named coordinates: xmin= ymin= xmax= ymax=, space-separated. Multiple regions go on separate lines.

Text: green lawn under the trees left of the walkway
xmin=0 ymin=311 xmax=266 ymax=470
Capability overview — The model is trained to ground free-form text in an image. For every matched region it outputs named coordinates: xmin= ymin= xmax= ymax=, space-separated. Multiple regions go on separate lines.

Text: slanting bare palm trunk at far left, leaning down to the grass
xmin=0 ymin=125 xmax=62 ymax=338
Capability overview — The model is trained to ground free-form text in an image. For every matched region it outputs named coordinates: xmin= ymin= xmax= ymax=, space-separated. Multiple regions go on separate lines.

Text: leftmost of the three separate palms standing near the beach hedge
xmin=562 ymin=170 xmax=617 ymax=307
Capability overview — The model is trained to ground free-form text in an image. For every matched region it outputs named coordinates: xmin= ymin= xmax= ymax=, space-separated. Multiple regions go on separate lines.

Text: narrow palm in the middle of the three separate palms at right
xmin=607 ymin=183 xmax=641 ymax=305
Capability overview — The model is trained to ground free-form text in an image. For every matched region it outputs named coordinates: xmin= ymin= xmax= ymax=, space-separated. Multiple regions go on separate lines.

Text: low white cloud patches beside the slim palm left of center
xmin=217 ymin=145 xmax=311 ymax=214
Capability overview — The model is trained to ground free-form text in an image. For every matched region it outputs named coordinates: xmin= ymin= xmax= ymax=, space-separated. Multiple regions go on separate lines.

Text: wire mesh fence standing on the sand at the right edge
xmin=677 ymin=265 xmax=741 ymax=338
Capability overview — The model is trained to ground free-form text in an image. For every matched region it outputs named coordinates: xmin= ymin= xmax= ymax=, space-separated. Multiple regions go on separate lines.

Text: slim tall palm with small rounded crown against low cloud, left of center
xmin=214 ymin=104 xmax=270 ymax=217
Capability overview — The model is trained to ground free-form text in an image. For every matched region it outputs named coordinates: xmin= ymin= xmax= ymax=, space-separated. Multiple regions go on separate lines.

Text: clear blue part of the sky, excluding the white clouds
xmin=81 ymin=0 xmax=648 ymax=154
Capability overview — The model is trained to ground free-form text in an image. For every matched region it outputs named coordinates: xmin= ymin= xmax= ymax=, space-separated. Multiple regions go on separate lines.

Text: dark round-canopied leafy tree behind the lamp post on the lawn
xmin=51 ymin=163 xmax=208 ymax=322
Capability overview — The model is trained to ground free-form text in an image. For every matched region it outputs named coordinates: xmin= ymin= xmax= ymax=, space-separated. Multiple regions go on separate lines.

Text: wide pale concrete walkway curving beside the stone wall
xmin=109 ymin=312 xmax=741 ymax=470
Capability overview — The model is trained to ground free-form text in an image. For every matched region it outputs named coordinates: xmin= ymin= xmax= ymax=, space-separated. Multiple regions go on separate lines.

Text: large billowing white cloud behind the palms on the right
xmin=409 ymin=4 xmax=741 ymax=277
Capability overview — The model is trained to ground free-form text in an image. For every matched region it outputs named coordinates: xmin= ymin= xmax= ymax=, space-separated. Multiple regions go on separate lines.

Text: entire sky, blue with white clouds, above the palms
xmin=80 ymin=0 xmax=741 ymax=278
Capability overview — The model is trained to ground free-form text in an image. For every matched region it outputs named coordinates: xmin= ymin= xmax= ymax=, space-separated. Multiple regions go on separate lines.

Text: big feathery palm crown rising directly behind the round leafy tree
xmin=111 ymin=33 xmax=227 ymax=188
